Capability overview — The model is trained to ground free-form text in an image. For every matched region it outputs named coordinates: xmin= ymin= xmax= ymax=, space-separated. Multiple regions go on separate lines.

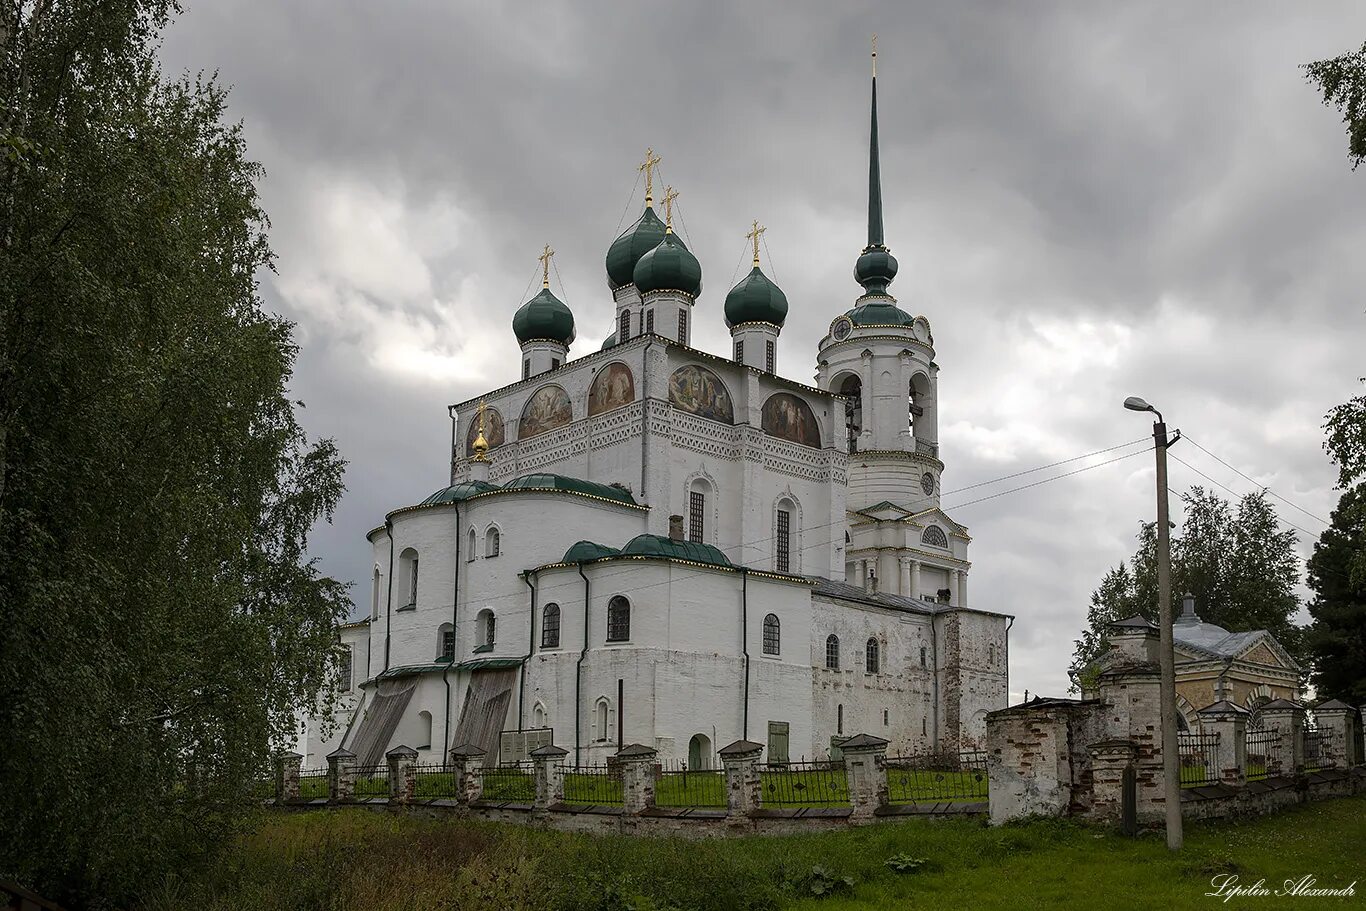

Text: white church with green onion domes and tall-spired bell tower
xmin=305 ymin=62 xmax=1011 ymax=768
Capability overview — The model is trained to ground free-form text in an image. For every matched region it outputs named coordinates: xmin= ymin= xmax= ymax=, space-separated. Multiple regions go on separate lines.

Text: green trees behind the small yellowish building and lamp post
xmin=1070 ymin=488 xmax=1305 ymax=691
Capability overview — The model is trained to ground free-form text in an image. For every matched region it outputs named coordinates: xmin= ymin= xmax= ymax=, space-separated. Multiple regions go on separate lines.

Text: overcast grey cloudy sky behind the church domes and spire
xmin=163 ymin=0 xmax=1366 ymax=698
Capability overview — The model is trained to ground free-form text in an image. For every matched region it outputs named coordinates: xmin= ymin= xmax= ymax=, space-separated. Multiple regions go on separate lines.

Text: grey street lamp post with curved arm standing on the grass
xmin=1124 ymin=396 xmax=1182 ymax=851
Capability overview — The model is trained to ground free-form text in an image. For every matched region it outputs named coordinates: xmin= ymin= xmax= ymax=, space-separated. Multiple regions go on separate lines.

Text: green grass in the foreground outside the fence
xmin=134 ymin=796 xmax=1366 ymax=911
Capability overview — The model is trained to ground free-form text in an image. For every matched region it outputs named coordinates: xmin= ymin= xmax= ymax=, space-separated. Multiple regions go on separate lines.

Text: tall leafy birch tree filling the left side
xmin=0 ymin=0 xmax=347 ymax=906
